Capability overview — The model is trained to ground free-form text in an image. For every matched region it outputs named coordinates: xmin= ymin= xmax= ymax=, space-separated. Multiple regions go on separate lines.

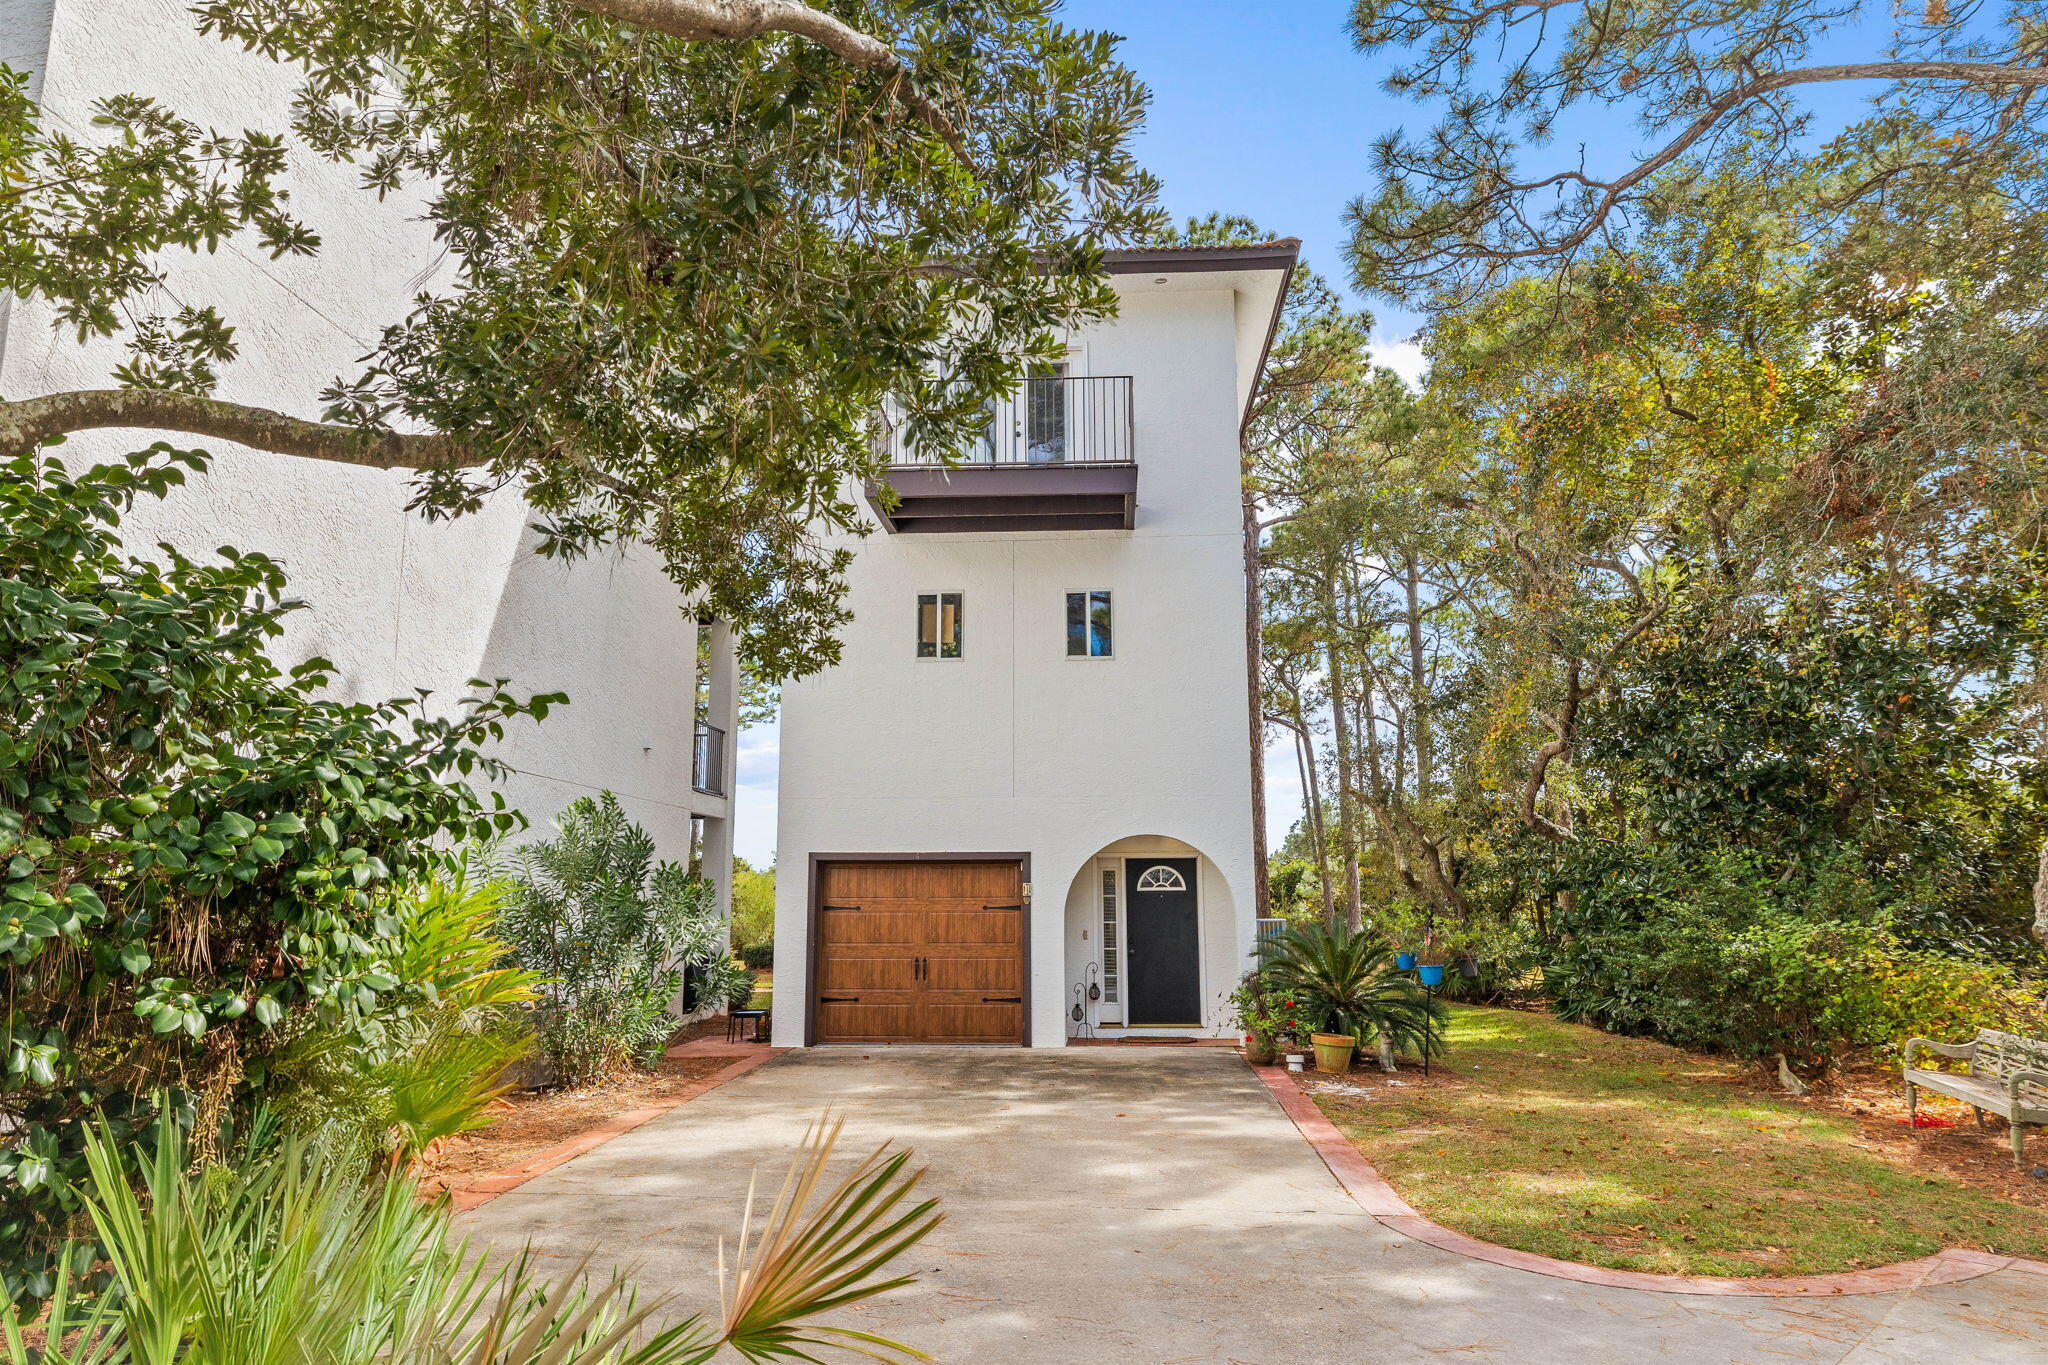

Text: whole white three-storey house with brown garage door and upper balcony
xmin=774 ymin=239 xmax=1298 ymax=1048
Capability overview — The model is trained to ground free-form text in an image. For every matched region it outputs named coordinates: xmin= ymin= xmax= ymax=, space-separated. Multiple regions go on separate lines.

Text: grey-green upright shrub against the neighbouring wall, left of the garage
xmin=500 ymin=792 xmax=723 ymax=1085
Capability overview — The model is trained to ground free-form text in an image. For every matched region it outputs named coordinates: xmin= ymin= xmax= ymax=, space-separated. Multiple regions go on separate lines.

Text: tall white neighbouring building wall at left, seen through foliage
xmin=0 ymin=0 xmax=733 ymax=875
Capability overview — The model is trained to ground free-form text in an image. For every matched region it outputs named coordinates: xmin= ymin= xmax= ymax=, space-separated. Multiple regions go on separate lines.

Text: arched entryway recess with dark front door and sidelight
xmin=1067 ymin=835 xmax=1239 ymax=1038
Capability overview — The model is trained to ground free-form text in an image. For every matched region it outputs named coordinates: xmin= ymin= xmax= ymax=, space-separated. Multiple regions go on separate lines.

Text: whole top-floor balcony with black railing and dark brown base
xmin=868 ymin=375 xmax=1139 ymax=534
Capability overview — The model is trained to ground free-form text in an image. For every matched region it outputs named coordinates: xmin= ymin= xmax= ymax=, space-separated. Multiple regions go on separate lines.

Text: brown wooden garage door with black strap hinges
xmin=813 ymin=862 xmax=1024 ymax=1044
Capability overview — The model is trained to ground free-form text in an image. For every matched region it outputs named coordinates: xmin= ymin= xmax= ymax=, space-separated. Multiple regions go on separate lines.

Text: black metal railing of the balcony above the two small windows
xmin=874 ymin=375 xmax=1133 ymax=467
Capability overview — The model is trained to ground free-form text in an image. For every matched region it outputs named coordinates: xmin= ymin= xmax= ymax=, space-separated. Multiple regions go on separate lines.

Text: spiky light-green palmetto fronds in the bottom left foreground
xmin=0 ymin=1124 xmax=940 ymax=1365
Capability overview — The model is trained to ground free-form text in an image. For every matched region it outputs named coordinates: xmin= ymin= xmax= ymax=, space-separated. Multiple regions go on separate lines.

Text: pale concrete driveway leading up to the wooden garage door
xmin=463 ymin=1048 xmax=2048 ymax=1365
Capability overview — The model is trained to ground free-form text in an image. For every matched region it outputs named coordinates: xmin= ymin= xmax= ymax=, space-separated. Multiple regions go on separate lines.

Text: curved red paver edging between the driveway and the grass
xmin=1251 ymin=1066 xmax=2048 ymax=1297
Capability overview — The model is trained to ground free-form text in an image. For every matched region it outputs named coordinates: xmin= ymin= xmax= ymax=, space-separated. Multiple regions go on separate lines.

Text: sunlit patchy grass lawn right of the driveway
xmin=1315 ymin=1007 xmax=2048 ymax=1275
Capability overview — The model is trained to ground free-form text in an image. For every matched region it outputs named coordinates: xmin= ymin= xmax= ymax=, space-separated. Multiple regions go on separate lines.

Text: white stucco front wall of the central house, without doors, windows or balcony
xmin=774 ymin=254 xmax=1286 ymax=1046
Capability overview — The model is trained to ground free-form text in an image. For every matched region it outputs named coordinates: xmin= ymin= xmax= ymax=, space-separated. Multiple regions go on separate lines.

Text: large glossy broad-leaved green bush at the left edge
xmin=0 ymin=446 xmax=561 ymax=1297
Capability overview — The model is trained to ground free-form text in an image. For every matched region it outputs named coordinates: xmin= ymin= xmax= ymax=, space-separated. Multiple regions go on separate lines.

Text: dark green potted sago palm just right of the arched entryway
xmin=1260 ymin=925 xmax=1446 ymax=1052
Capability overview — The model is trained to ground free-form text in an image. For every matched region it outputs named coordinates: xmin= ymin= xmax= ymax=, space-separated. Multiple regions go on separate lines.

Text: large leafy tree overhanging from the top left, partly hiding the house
xmin=0 ymin=0 xmax=1157 ymax=677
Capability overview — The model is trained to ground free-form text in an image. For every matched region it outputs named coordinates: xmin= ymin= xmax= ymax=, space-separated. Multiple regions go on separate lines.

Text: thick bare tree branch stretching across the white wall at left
xmin=0 ymin=389 xmax=489 ymax=469
